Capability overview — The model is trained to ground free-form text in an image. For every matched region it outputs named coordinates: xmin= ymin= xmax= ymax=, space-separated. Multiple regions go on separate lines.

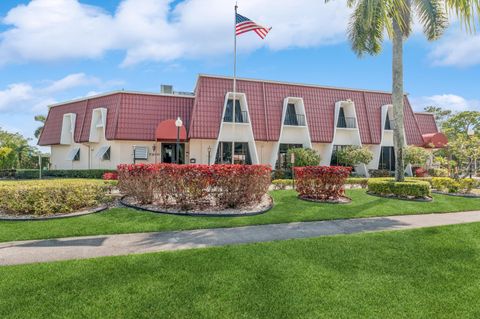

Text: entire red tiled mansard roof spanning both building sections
xmin=39 ymin=75 xmax=437 ymax=145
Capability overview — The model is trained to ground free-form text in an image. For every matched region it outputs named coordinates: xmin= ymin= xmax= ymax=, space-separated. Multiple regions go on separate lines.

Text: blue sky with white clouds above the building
xmin=0 ymin=0 xmax=480 ymax=146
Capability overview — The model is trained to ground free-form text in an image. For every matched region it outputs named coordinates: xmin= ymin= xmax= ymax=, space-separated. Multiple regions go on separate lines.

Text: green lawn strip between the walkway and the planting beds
xmin=0 ymin=189 xmax=480 ymax=242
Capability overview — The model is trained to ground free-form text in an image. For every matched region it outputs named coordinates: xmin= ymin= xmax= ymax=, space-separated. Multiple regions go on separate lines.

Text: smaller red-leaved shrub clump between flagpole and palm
xmin=294 ymin=166 xmax=352 ymax=200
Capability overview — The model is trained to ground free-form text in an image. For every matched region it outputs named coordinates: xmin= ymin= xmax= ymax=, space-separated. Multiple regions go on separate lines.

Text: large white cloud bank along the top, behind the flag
xmin=0 ymin=0 xmax=350 ymax=65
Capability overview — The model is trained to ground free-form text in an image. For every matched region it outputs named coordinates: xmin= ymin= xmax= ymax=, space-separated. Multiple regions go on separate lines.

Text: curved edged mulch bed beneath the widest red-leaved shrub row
xmin=120 ymin=194 xmax=273 ymax=217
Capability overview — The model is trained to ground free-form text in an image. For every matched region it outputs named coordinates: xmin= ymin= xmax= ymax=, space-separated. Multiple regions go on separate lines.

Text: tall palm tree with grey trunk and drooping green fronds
xmin=326 ymin=0 xmax=462 ymax=181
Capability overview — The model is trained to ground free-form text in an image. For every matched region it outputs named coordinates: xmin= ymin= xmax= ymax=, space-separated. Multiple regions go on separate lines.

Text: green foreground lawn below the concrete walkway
xmin=0 ymin=223 xmax=480 ymax=319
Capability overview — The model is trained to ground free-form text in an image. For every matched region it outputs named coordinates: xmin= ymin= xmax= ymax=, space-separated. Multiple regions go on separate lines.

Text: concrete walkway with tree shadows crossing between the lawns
xmin=0 ymin=211 xmax=480 ymax=265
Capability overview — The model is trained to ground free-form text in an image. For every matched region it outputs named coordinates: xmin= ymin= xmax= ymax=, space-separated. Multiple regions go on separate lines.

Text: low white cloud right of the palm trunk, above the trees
xmin=410 ymin=94 xmax=480 ymax=111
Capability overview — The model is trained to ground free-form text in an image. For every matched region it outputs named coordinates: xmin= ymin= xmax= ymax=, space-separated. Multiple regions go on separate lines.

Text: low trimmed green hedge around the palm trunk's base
xmin=368 ymin=179 xmax=431 ymax=198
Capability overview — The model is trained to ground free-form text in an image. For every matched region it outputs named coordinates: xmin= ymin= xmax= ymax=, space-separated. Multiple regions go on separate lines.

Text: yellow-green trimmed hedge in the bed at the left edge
xmin=0 ymin=180 xmax=111 ymax=216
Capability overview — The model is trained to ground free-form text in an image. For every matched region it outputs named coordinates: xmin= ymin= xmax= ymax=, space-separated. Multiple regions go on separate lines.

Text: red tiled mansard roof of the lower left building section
xmin=38 ymin=92 xmax=194 ymax=145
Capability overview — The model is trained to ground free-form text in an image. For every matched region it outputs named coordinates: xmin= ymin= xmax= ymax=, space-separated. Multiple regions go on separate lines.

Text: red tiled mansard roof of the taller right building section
xmin=189 ymin=76 xmax=423 ymax=145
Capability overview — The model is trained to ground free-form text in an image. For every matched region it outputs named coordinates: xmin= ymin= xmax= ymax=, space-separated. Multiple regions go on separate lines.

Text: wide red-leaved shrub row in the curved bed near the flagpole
xmin=118 ymin=164 xmax=271 ymax=210
